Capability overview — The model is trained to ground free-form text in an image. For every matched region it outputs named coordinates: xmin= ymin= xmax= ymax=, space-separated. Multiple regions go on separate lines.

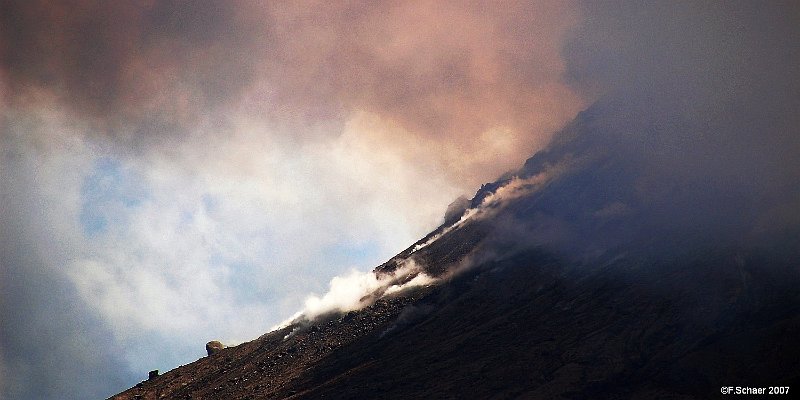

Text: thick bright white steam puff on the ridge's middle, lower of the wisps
xmin=272 ymin=259 xmax=435 ymax=330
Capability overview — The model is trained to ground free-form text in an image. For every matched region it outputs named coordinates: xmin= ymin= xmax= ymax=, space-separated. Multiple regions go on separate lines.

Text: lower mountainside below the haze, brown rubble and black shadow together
xmin=111 ymin=245 xmax=800 ymax=399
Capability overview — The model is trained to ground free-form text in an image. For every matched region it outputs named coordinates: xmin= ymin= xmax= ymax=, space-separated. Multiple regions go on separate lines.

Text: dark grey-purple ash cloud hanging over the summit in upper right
xmin=565 ymin=1 xmax=800 ymax=238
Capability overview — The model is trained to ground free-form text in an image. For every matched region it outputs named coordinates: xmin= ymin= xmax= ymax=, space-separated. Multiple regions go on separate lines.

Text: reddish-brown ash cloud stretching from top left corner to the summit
xmin=0 ymin=1 xmax=583 ymax=186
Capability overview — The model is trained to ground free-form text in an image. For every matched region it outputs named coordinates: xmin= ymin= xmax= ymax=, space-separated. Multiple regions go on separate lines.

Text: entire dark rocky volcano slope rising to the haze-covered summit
xmin=112 ymin=110 xmax=800 ymax=400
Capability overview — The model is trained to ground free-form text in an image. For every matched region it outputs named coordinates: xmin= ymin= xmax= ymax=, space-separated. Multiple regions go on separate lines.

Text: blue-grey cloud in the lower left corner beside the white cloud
xmin=0 ymin=138 xmax=138 ymax=399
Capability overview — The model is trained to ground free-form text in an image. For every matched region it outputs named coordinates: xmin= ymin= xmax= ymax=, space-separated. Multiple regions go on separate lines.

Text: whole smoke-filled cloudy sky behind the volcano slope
xmin=0 ymin=0 xmax=800 ymax=399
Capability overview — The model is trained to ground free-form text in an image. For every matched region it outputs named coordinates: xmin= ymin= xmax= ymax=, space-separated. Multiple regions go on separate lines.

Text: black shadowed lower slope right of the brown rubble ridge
xmin=300 ymin=253 xmax=800 ymax=399
